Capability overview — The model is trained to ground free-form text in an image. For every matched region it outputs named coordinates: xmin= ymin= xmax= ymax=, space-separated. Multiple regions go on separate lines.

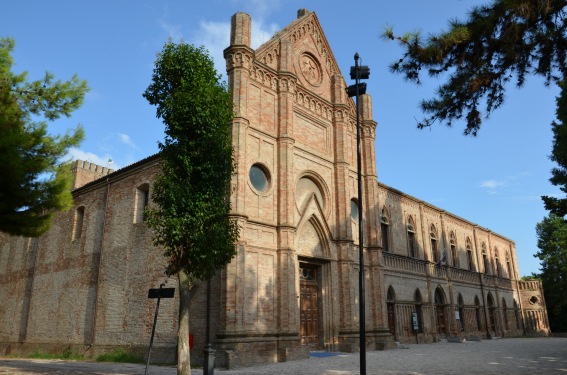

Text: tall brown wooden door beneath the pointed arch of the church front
xmin=299 ymin=266 xmax=319 ymax=349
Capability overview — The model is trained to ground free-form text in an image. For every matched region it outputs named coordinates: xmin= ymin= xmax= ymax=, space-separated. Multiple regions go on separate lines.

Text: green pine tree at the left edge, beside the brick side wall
xmin=0 ymin=38 xmax=88 ymax=237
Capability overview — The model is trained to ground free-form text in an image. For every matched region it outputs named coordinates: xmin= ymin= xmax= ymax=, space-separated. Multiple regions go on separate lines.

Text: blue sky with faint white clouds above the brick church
xmin=0 ymin=0 xmax=559 ymax=275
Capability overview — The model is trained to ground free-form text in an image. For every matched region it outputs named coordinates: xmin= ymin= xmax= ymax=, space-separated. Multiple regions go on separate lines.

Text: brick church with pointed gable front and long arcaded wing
xmin=0 ymin=10 xmax=550 ymax=367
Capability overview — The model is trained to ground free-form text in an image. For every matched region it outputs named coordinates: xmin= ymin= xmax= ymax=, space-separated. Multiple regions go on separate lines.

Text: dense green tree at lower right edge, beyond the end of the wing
xmin=534 ymin=214 xmax=567 ymax=332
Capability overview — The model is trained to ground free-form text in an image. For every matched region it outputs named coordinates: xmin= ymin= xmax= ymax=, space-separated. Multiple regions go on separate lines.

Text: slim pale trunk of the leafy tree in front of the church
xmin=177 ymin=271 xmax=191 ymax=375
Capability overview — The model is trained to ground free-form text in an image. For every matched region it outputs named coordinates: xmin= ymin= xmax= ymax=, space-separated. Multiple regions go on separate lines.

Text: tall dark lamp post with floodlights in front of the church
xmin=346 ymin=52 xmax=370 ymax=375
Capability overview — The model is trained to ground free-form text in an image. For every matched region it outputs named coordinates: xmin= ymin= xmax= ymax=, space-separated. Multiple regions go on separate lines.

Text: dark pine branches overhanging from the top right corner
xmin=384 ymin=0 xmax=567 ymax=135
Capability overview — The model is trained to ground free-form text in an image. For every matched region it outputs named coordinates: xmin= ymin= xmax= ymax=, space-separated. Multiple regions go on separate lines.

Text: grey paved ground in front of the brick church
xmin=0 ymin=338 xmax=567 ymax=375
